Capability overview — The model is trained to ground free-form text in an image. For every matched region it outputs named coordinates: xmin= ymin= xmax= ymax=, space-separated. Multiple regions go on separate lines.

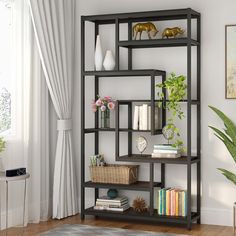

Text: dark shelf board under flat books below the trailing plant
xmin=116 ymin=154 xmax=200 ymax=165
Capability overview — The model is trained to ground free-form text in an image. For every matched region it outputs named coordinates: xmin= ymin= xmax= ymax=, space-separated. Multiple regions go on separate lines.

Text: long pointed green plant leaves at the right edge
xmin=209 ymin=106 xmax=236 ymax=185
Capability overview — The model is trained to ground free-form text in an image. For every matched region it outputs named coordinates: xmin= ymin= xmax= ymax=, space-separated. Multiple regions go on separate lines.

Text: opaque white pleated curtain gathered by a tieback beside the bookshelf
xmin=29 ymin=0 xmax=78 ymax=219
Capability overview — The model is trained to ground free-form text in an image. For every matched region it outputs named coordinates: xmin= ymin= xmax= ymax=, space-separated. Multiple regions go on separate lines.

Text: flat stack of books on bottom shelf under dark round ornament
xmin=94 ymin=196 xmax=129 ymax=212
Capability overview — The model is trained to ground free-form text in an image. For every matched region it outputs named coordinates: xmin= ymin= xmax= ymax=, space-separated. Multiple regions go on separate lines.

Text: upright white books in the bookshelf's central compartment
xmin=133 ymin=104 xmax=161 ymax=130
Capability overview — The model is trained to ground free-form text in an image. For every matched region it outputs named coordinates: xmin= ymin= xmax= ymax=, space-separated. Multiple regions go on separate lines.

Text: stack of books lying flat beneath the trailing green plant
xmin=152 ymin=144 xmax=181 ymax=158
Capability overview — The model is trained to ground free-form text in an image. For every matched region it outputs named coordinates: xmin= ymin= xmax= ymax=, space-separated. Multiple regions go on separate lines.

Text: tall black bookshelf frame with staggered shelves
xmin=81 ymin=8 xmax=201 ymax=229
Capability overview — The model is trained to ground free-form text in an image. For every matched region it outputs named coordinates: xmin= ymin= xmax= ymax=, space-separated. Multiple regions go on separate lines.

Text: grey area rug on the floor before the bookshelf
xmin=39 ymin=224 xmax=190 ymax=236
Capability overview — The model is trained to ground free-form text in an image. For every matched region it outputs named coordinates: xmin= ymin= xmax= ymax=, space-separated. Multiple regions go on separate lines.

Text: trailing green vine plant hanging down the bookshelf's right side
xmin=156 ymin=72 xmax=187 ymax=147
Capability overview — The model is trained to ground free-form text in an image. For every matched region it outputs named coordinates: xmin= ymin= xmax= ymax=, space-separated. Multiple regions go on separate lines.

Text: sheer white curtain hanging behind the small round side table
xmin=0 ymin=0 xmax=51 ymax=229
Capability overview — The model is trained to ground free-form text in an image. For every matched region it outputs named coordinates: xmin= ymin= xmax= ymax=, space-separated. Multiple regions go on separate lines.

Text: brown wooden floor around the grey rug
xmin=0 ymin=215 xmax=233 ymax=236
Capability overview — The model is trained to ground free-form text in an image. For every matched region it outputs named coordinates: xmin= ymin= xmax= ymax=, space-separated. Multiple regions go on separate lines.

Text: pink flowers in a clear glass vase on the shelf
xmin=92 ymin=96 xmax=115 ymax=128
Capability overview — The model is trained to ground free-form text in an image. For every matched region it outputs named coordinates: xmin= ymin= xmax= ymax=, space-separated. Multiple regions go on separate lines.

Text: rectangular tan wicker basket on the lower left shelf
xmin=89 ymin=165 xmax=139 ymax=184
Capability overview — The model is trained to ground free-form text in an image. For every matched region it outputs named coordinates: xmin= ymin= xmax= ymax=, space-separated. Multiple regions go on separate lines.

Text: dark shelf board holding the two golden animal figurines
xmin=118 ymin=38 xmax=199 ymax=48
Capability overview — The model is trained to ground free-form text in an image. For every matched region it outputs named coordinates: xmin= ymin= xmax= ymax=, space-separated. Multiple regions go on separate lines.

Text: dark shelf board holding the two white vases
xmin=82 ymin=69 xmax=166 ymax=77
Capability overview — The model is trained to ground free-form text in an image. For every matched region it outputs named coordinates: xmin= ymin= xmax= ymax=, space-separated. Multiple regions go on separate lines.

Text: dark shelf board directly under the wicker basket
xmin=83 ymin=181 xmax=161 ymax=192
